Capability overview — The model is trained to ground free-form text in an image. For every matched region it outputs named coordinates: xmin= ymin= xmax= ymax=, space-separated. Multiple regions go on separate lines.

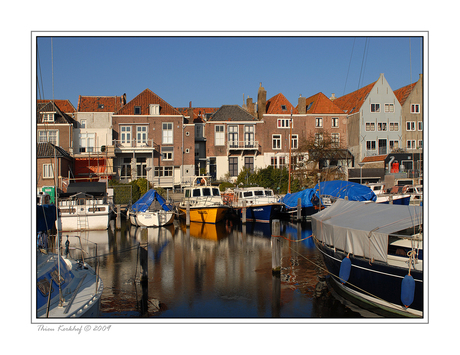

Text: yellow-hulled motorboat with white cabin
xmin=179 ymin=176 xmax=230 ymax=223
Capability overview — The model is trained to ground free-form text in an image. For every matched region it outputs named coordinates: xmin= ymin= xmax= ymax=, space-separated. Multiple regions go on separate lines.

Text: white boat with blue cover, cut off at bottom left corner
xmin=35 ymin=200 xmax=104 ymax=318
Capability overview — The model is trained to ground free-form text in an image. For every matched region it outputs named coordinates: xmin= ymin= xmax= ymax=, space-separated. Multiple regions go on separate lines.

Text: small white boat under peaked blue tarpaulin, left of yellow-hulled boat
xmin=128 ymin=189 xmax=175 ymax=227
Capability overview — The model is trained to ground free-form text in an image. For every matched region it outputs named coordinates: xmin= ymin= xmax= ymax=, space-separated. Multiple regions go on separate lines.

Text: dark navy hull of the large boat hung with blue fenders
xmin=315 ymin=239 xmax=423 ymax=317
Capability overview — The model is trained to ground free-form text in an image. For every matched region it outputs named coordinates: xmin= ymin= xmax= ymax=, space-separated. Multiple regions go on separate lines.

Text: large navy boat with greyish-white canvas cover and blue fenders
xmin=312 ymin=200 xmax=424 ymax=317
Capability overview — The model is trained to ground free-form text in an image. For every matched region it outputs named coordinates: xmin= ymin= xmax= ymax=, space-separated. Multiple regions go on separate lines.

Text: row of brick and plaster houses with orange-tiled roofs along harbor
xmin=36 ymin=74 xmax=423 ymax=195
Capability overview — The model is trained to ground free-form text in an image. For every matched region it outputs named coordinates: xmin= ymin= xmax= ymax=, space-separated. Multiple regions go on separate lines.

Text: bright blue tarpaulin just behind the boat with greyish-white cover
xmin=314 ymin=180 xmax=377 ymax=201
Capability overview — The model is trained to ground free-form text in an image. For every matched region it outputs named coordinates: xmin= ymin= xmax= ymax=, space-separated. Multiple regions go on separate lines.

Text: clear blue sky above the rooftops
xmin=35 ymin=32 xmax=422 ymax=108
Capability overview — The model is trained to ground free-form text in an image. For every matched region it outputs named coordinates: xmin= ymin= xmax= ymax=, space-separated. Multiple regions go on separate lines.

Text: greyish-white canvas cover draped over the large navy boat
xmin=311 ymin=199 xmax=423 ymax=262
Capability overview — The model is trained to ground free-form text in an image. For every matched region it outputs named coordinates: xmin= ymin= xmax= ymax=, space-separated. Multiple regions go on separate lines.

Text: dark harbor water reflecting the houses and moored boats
xmin=72 ymin=220 xmax=373 ymax=321
